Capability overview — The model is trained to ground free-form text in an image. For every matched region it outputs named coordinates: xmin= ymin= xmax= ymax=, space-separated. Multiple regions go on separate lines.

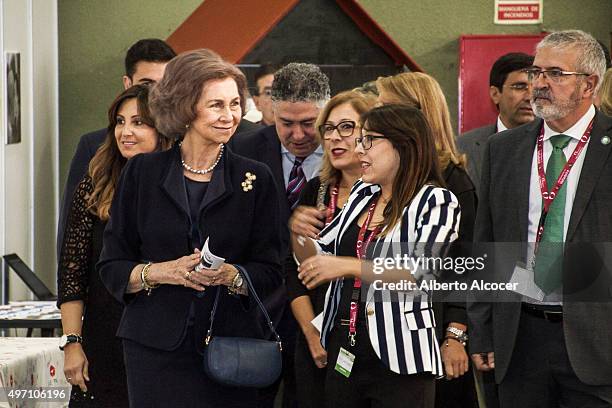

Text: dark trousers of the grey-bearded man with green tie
xmin=499 ymin=311 xmax=612 ymax=408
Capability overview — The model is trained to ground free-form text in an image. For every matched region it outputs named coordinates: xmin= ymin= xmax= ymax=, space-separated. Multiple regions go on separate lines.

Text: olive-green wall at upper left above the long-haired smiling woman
xmin=59 ymin=0 xmax=202 ymax=193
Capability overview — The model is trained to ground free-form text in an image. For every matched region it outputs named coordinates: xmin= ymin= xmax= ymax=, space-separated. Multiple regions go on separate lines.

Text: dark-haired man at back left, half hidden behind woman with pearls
xmin=57 ymin=38 xmax=176 ymax=255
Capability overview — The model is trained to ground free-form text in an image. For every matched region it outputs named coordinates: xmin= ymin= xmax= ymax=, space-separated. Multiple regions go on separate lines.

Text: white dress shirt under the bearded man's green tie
xmin=527 ymin=105 xmax=595 ymax=304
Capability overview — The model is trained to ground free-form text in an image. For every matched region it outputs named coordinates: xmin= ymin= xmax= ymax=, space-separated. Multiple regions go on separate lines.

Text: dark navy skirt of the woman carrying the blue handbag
xmin=123 ymin=327 xmax=257 ymax=408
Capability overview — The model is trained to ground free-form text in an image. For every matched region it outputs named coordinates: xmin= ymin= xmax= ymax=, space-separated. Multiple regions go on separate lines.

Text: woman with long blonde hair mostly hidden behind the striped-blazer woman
xmin=376 ymin=72 xmax=478 ymax=408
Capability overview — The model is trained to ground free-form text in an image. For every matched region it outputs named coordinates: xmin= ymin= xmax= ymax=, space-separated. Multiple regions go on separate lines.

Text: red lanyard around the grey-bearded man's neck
xmin=536 ymin=120 xmax=593 ymax=244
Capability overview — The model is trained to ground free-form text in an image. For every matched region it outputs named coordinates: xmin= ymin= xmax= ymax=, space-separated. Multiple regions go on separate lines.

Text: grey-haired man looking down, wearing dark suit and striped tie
xmin=229 ymin=63 xmax=330 ymax=407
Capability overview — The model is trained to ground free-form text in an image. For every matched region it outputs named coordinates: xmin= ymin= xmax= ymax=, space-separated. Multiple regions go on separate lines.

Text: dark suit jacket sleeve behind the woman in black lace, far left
xmin=57 ymin=128 xmax=107 ymax=259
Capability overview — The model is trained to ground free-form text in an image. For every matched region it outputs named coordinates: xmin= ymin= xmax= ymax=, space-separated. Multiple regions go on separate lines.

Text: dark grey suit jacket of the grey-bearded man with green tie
xmin=468 ymin=112 xmax=612 ymax=385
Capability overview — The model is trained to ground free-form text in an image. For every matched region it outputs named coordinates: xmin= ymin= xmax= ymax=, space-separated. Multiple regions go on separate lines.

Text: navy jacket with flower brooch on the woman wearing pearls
xmin=97 ymin=146 xmax=281 ymax=350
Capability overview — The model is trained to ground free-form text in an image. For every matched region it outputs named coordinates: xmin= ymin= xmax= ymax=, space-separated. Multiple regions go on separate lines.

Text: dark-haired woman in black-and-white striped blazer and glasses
xmin=291 ymin=105 xmax=460 ymax=407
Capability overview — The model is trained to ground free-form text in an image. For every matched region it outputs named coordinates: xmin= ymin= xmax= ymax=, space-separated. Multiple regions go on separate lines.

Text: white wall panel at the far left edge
xmin=0 ymin=0 xmax=58 ymax=300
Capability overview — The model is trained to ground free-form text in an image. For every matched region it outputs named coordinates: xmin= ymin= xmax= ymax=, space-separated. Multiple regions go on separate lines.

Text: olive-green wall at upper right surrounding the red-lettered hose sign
xmin=358 ymin=0 xmax=612 ymax=131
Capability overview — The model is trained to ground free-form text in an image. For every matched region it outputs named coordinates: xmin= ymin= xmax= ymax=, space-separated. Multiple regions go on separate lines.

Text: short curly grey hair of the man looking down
xmin=272 ymin=62 xmax=330 ymax=108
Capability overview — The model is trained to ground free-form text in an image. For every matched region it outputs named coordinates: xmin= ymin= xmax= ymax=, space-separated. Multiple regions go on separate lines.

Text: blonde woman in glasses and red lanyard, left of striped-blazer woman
xmin=287 ymin=91 xmax=376 ymax=408
